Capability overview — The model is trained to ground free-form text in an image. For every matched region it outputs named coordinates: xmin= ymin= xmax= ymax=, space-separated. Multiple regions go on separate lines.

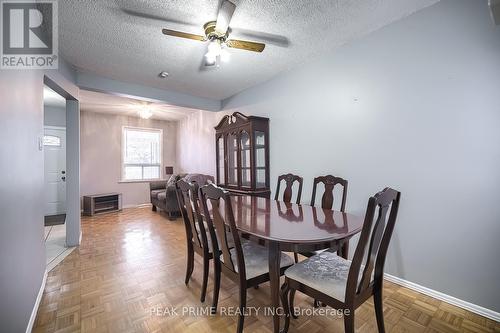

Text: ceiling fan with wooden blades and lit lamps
xmin=162 ymin=0 xmax=266 ymax=67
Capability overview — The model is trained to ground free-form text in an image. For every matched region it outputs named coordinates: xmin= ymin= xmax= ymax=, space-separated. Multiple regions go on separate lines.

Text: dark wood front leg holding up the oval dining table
xmin=269 ymin=242 xmax=281 ymax=333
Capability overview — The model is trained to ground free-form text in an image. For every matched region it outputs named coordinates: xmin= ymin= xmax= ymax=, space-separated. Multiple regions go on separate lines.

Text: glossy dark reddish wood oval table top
xmin=221 ymin=196 xmax=363 ymax=244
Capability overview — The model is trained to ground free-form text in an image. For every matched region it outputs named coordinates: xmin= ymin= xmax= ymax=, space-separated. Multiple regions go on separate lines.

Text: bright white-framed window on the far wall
xmin=122 ymin=127 xmax=163 ymax=180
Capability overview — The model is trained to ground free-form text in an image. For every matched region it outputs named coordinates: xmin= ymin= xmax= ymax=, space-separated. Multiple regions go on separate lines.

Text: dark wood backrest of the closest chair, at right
xmin=346 ymin=187 xmax=401 ymax=300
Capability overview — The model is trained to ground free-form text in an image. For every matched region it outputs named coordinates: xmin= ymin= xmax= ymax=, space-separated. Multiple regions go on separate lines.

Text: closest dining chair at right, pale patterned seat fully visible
xmin=281 ymin=188 xmax=401 ymax=333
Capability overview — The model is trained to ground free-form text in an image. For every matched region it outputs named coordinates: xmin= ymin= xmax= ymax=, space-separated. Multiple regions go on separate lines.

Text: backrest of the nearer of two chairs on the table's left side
xmin=200 ymin=184 xmax=246 ymax=278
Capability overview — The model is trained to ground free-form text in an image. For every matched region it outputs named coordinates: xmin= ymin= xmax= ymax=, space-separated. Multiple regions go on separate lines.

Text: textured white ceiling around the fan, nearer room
xmin=59 ymin=0 xmax=438 ymax=99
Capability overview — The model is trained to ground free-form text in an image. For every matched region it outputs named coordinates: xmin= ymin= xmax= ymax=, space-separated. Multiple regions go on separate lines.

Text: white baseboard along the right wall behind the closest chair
xmin=384 ymin=274 xmax=500 ymax=322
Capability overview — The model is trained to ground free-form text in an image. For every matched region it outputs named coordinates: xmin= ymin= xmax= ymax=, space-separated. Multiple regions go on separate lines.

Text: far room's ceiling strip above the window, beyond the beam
xmin=79 ymin=90 xmax=197 ymax=121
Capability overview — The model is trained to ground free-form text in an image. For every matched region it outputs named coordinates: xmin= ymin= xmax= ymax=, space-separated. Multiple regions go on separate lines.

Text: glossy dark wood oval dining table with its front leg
xmin=224 ymin=195 xmax=363 ymax=333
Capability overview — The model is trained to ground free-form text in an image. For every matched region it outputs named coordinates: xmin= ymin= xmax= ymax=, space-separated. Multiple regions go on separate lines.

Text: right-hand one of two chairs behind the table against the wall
xmin=303 ymin=175 xmax=349 ymax=259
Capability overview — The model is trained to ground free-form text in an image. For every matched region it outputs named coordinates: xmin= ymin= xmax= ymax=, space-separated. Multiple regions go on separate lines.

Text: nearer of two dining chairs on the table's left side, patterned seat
xmin=200 ymin=184 xmax=293 ymax=333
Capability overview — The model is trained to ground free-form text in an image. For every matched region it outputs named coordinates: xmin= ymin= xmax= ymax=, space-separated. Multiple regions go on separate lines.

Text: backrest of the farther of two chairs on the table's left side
xmin=175 ymin=179 xmax=208 ymax=248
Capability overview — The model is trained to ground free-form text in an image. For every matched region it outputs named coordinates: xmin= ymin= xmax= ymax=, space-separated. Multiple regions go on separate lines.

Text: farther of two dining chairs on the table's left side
xmin=176 ymin=180 xmax=214 ymax=302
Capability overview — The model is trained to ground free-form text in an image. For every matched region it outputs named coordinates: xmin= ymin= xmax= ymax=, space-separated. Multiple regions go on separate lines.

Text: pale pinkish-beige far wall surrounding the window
xmin=80 ymin=111 xmax=179 ymax=206
